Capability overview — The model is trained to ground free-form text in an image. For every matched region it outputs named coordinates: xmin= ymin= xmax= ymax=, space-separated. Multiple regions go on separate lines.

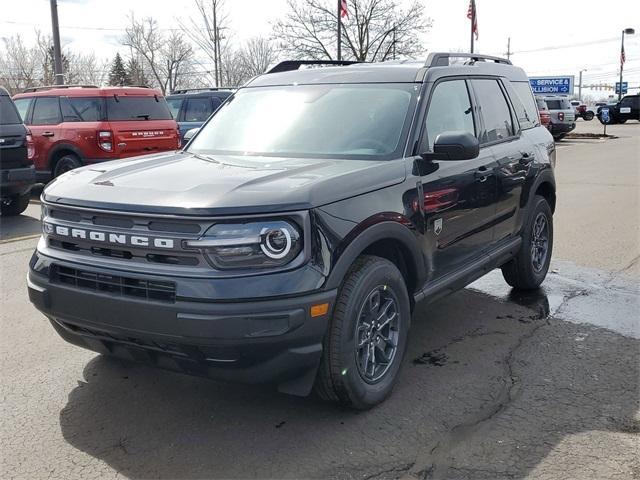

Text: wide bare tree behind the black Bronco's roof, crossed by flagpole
xmin=274 ymin=0 xmax=431 ymax=62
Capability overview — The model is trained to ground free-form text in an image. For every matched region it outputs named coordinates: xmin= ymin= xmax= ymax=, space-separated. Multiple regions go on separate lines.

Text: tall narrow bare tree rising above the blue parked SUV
xmin=180 ymin=0 xmax=230 ymax=87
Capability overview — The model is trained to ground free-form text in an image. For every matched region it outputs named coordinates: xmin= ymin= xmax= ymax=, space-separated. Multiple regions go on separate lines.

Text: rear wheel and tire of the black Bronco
xmin=502 ymin=195 xmax=553 ymax=290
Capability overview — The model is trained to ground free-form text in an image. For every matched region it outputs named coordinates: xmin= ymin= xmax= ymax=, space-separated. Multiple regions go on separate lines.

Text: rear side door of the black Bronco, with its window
xmin=471 ymin=78 xmax=536 ymax=244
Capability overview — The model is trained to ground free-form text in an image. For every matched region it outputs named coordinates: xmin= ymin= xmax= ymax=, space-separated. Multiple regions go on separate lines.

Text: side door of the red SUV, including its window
xmin=29 ymin=97 xmax=62 ymax=172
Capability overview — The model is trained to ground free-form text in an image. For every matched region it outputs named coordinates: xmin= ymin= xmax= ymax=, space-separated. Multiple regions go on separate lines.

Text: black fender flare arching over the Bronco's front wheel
xmin=324 ymin=220 xmax=426 ymax=295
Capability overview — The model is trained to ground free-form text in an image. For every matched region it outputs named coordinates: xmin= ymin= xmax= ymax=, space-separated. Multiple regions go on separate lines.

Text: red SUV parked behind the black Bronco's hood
xmin=13 ymin=85 xmax=180 ymax=182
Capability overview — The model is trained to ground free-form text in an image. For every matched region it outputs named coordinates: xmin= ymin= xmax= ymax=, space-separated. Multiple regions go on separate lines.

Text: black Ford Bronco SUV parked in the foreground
xmin=28 ymin=53 xmax=556 ymax=409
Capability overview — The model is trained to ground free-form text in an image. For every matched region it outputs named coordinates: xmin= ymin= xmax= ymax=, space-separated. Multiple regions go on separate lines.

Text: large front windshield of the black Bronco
xmin=189 ymin=84 xmax=417 ymax=160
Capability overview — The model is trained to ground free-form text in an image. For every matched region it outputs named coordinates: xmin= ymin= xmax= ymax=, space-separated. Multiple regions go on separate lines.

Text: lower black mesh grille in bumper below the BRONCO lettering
xmin=50 ymin=265 xmax=176 ymax=303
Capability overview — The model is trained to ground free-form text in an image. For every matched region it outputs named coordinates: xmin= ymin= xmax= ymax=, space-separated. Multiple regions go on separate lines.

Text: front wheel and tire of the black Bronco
xmin=314 ymin=255 xmax=411 ymax=410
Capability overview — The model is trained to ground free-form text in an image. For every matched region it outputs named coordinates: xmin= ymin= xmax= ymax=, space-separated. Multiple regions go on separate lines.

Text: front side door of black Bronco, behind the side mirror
xmin=418 ymin=78 xmax=496 ymax=278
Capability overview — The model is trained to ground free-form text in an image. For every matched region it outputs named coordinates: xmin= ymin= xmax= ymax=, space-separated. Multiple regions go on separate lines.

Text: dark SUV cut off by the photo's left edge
xmin=0 ymin=87 xmax=35 ymax=216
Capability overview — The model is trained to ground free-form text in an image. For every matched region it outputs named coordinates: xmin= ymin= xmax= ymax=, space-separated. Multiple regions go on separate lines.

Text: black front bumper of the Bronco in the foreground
xmin=27 ymin=252 xmax=336 ymax=395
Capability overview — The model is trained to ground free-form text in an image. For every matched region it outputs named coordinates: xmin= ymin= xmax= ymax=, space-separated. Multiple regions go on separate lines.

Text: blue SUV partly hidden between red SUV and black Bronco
xmin=167 ymin=88 xmax=233 ymax=140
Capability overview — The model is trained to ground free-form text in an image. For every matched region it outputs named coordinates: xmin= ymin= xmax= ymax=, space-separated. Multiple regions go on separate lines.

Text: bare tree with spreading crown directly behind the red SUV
xmin=123 ymin=15 xmax=193 ymax=94
